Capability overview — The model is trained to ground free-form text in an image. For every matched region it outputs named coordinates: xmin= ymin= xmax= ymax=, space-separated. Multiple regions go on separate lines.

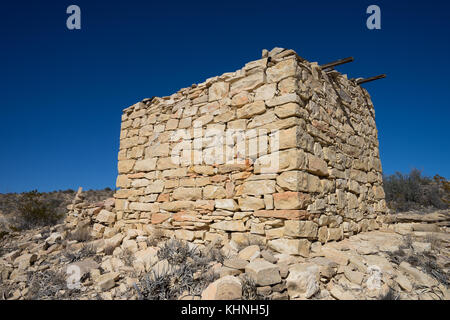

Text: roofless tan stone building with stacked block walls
xmin=111 ymin=48 xmax=387 ymax=256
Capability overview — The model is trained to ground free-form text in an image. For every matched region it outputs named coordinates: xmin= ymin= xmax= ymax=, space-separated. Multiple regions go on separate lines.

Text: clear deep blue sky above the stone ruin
xmin=0 ymin=0 xmax=450 ymax=193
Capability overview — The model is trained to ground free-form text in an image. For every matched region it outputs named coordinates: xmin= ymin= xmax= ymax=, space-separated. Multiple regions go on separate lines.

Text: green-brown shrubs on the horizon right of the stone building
xmin=383 ymin=169 xmax=450 ymax=211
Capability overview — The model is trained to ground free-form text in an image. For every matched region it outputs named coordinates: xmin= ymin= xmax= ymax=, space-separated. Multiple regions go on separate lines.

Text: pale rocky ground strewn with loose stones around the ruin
xmin=0 ymin=190 xmax=450 ymax=300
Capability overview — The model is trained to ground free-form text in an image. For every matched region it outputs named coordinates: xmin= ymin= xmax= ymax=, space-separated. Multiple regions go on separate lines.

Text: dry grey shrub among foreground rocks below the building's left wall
xmin=134 ymin=240 xmax=218 ymax=300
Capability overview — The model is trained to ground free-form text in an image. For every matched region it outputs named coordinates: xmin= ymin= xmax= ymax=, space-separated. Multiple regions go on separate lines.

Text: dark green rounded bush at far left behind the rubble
xmin=14 ymin=190 xmax=63 ymax=230
